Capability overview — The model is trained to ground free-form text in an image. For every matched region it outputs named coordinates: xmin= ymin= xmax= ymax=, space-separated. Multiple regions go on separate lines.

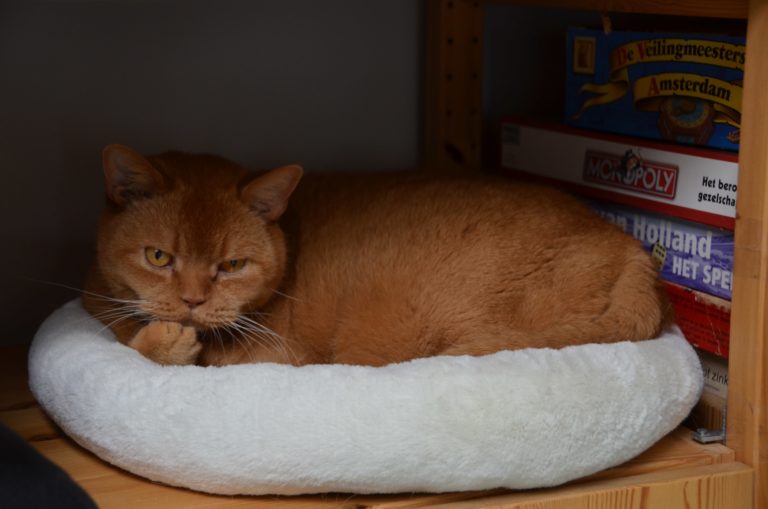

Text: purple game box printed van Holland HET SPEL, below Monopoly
xmin=588 ymin=201 xmax=733 ymax=300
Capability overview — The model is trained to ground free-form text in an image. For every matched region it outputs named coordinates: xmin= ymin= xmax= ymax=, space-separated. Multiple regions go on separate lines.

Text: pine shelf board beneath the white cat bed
xmin=0 ymin=347 xmax=752 ymax=509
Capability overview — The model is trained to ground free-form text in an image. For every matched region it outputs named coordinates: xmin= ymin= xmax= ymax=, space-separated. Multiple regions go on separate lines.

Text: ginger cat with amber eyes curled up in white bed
xmin=83 ymin=145 xmax=668 ymax=366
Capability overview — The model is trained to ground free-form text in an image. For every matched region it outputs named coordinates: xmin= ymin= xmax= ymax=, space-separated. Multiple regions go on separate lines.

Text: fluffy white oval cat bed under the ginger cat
xmin=29 ymin=301 xmax=702 ymax=495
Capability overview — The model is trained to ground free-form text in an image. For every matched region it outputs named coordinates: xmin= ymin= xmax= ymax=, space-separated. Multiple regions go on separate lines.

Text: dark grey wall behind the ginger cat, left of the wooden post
xmin=0 ymin=0 xmax=421 ymax=344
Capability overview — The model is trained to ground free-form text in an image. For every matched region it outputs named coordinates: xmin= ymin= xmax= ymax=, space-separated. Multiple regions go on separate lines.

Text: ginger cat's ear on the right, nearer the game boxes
xmin=240 ymin=165 xmax=304 ymax=221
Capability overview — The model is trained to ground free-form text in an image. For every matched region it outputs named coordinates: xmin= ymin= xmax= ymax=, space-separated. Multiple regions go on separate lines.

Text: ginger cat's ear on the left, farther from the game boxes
xmin=102 ymin=144 xmax=165 ymax=206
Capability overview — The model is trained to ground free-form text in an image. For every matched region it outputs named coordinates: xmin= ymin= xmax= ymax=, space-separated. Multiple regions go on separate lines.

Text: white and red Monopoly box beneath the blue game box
xmin=501 ymin=118 xmax=738 ymax=230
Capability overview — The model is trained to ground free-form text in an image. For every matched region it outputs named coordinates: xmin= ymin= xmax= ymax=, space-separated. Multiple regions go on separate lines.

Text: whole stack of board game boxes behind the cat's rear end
xmin=501 ymin=28 xmax=744 ymax=429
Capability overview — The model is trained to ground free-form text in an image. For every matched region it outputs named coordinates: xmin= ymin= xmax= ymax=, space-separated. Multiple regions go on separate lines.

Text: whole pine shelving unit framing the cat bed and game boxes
xmin=0 ymin=0 xmax=768 ymax=509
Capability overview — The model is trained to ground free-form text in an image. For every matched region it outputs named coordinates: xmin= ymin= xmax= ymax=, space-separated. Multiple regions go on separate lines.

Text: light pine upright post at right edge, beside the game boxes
xmin=726 ymin=0 xmax=768 ymax=508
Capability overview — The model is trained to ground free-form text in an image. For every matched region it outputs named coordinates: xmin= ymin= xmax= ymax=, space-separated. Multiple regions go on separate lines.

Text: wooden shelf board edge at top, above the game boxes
xmin=485 ymin=0 xmax=748 ymax=19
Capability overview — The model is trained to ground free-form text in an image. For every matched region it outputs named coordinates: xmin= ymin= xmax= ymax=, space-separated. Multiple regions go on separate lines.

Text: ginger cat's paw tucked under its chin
xmin=128 ymin=321 xmax=203 ymax=365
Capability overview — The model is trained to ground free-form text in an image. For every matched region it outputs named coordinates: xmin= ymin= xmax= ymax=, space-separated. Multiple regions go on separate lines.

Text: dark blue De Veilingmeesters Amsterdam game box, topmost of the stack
xmin=565 ymin=28 xmax=745 ymax=151
